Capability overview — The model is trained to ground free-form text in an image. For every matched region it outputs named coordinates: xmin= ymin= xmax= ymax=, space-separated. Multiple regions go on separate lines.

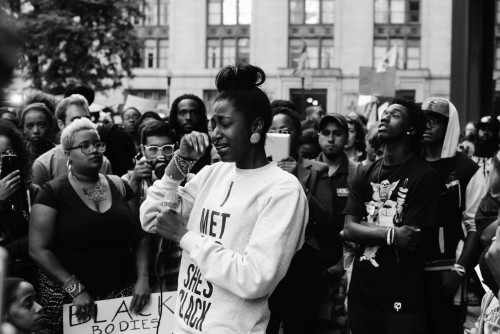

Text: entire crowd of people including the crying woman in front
xmin=0 ymin=65 xmax=500 ymax=334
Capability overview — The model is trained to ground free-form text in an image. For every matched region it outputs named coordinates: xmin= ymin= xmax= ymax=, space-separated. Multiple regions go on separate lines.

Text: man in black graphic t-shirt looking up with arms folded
xmin=344 ymin=98 xmax=441 ymax=334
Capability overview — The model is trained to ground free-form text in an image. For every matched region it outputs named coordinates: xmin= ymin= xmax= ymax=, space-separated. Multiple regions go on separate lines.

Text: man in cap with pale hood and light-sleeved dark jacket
xmin=422 ymin=97 xmax=483 ymax=334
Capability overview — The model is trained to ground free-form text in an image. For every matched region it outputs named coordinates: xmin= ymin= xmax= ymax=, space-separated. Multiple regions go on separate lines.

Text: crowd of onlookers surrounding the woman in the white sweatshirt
xmin=0 ymin=75 xmax=500 ymax=333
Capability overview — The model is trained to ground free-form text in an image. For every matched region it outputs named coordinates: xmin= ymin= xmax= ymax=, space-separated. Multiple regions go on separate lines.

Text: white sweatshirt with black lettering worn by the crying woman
xmin=141 ymin=162 xmax=308 ymax=334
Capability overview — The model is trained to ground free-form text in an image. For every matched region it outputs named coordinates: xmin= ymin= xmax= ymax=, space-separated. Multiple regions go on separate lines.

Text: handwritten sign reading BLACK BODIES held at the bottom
xmin=63 ymin=292 xmax=177 ymax=334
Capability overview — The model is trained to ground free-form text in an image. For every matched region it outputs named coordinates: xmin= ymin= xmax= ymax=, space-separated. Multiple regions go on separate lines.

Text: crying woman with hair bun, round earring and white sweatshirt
xmin=141 ymin=65 xmax=308 ymax=334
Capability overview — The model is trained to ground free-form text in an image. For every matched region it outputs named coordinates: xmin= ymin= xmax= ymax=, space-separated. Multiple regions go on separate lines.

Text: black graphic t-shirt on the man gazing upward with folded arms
xmin=345 ymin=155 xmax=441 ymax=312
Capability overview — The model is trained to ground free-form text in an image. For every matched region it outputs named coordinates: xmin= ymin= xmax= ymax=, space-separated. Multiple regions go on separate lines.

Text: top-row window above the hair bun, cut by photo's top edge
xmin=208 ymin=0 xmax=252 ymax=25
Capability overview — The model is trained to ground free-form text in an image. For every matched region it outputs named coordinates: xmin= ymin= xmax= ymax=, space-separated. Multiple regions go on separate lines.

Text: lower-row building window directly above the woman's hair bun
xmin=207 ymin=38 xmax=250 ymax=68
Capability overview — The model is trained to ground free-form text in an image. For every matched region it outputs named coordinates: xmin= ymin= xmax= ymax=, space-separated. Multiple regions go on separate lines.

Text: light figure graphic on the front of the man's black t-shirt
xmin=359 ymin=179 xmax=408 ymax=268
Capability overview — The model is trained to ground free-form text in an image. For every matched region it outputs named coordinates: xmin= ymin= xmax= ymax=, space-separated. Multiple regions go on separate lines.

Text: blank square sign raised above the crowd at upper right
xmin=359 ymin=67 xmax=396 ymax=96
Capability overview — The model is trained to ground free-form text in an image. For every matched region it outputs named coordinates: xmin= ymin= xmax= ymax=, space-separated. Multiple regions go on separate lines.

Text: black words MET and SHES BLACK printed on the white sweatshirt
xmin=178 ymin=208 xmax=231 ymax=332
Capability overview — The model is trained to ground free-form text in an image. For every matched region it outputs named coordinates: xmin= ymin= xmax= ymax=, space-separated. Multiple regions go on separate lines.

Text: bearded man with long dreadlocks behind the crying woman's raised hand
xmin=168 ymin=94 xmax=212 ymax=174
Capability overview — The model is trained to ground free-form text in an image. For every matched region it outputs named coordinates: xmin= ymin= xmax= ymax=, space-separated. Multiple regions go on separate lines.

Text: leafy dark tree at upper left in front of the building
xmin=10 ymin=0 xmax=141 ymax=94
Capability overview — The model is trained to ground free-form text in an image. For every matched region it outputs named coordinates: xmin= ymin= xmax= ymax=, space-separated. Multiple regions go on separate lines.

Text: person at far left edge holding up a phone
xmin=0 ymin=120 xmax=39 ymax=283
